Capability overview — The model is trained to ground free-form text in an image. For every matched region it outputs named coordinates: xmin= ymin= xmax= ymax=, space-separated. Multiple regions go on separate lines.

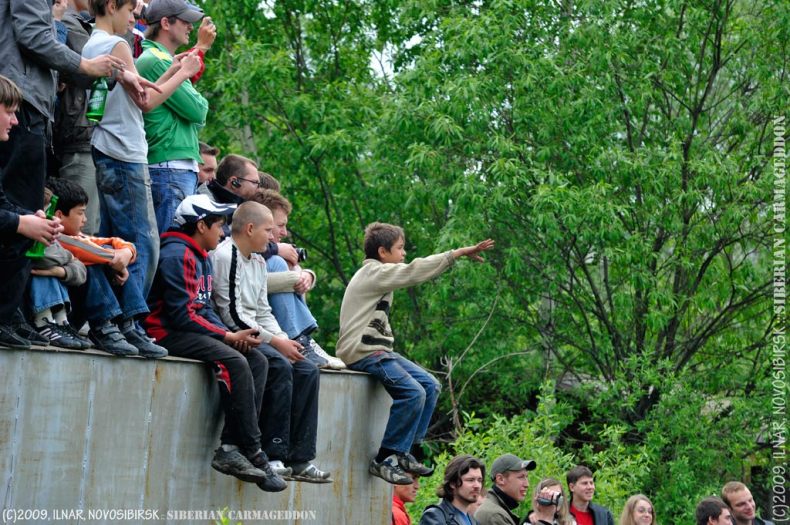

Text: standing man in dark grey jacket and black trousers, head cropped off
xmin=0 ymin=0 xmax=124 ymax=348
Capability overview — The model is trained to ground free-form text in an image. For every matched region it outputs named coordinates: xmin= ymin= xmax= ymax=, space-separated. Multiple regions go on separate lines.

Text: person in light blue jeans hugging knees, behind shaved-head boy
xmin=253 ymin=190 xmax=346 ymax=370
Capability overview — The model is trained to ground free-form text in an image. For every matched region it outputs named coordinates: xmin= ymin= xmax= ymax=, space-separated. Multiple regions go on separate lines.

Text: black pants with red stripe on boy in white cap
xmin=158 ymin=332 xmax=269 ymax=454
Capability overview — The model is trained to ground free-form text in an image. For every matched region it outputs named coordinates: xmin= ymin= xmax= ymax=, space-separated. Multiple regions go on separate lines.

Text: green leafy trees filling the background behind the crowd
xmin=199 ymin=0 xmax=790 ymax=523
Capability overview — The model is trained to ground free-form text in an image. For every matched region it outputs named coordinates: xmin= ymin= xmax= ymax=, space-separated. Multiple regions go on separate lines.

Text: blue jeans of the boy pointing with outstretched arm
xmin=348 ymin=352 xmax=441 ymax=453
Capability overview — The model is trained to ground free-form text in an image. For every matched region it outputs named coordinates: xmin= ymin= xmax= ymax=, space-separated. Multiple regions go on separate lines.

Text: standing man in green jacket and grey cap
xmin=137 ymin=0 xmax=208 ymax=234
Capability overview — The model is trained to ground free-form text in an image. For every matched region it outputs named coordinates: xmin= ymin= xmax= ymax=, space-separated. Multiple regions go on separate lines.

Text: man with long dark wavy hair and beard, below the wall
xmin=420 ymin=454 xmax=486 ymax=525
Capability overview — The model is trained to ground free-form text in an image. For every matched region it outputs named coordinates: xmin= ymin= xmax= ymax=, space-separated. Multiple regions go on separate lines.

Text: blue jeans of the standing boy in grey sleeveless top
xmin=93 ymin=148 xmax=159 ymax=297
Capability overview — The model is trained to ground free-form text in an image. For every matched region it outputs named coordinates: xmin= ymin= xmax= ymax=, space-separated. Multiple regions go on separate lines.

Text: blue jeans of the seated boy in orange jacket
xmin=69 ymin=264 xmax=148 ymax=326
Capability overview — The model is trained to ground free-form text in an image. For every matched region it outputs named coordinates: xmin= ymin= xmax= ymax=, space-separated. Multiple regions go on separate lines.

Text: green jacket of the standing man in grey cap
xmin=135 ymin=40 xmax=208 ymax=164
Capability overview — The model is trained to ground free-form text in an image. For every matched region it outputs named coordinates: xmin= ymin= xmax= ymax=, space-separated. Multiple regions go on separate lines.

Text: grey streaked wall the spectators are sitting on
xmin=0 ymin=348 xmax=391 ymax=525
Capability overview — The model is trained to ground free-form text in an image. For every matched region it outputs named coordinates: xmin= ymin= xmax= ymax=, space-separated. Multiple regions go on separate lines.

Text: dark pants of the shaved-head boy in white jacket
xmin=258 ymin=343 xmax=320 ymax=463
